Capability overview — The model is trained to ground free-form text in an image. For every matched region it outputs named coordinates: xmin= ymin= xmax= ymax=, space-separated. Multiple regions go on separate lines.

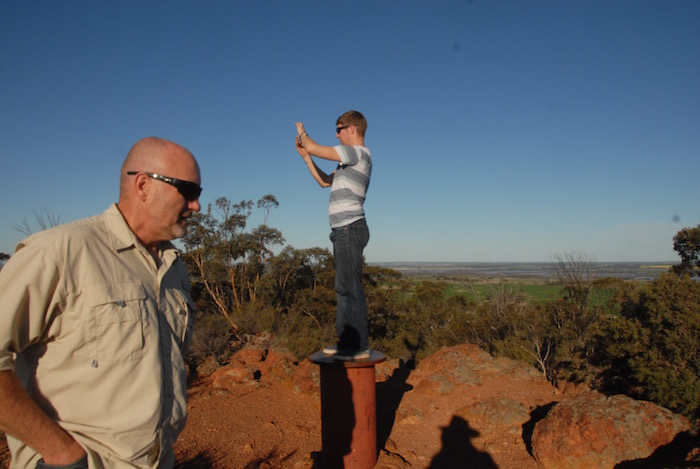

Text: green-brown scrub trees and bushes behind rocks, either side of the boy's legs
xmin=184 ymin=195 xmax=700 ymax=418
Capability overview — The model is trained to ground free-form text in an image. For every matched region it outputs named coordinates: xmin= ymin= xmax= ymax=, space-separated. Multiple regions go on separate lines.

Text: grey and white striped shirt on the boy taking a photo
xmin=328 ymin=145 xmax=372 ymax=228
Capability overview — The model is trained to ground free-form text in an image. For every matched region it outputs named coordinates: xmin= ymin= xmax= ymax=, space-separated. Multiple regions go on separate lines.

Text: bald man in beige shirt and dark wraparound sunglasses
xmin=0 ymin=137 xmax=201 ymax=469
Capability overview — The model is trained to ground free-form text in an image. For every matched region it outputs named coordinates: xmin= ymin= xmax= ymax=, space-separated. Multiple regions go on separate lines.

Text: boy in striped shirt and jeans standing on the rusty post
xmin=296 ymin=111 xmax=372 ymax=360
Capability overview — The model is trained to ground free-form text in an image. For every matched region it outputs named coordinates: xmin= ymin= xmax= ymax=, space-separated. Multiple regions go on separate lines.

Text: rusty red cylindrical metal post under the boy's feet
xmin=309 ymin=350 xmax=386 ymax=469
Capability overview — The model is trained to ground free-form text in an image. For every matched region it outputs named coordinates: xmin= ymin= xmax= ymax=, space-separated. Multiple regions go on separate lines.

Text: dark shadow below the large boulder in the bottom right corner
xmin=615 ymin=431 xmax=700 ymax=469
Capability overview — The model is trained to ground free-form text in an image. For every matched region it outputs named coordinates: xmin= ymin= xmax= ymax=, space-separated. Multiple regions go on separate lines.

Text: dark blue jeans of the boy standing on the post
xmin=331 ymin=218 xmax=369 ymax=351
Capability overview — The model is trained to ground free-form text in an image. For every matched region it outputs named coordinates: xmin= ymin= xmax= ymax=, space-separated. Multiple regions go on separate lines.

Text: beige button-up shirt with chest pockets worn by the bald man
xmin=0 ymin=205 xmax=194 ymax=469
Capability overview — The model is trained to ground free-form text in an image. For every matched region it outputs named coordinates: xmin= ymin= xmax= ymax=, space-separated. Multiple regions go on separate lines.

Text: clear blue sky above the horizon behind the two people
xmin=0 ymin=0 xmax=700 ymax=262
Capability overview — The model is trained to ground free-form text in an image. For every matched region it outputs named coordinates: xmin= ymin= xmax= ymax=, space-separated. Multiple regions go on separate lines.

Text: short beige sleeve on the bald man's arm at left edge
xmin=0 ymin=239 xmax=60 ymax=371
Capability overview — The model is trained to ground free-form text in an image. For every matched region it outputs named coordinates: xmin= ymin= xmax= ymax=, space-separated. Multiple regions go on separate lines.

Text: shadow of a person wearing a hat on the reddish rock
xmin=429 ymin=416 xmax=498 ymax=469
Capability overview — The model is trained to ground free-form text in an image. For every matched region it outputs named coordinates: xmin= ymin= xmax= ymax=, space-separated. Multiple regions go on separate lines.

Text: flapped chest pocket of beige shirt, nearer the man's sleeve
xmin=83 ymin=283 xmax=147 ymax=367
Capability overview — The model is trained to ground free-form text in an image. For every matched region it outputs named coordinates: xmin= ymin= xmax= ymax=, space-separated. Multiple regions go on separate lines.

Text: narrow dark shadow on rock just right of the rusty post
xmin=376 ymin=359 xmax=415 ymax=451
